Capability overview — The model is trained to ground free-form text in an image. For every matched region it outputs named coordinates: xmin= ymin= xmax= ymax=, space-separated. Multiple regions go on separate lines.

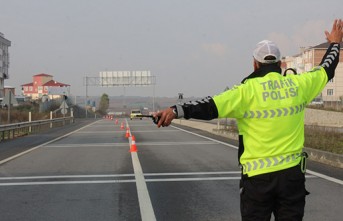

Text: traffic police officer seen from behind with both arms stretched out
xmin=155 ymin=19 xmax=343 ymax=221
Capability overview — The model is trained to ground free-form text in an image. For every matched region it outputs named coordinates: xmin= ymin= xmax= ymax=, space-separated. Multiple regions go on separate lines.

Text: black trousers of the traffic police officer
xmin=240 ymin=166 xmax=309 ymax=221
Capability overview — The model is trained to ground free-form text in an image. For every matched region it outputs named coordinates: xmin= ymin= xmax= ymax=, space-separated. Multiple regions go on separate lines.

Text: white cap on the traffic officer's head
xmin=253 ymin=40 xmax=281 ymax=64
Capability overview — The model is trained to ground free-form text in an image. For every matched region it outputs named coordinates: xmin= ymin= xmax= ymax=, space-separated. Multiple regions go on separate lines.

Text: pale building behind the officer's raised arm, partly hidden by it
xmin=282 ymin=43 xmax=343 ymax=103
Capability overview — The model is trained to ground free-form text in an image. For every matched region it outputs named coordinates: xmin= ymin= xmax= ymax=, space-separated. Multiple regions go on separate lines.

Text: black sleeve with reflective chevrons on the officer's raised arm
xmin=319 ymin=43 xmax=340 ymax=80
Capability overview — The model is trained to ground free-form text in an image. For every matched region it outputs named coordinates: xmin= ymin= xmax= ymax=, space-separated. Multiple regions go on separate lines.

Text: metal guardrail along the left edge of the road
xmin=0 ymin=117 xmax=74 ymax=142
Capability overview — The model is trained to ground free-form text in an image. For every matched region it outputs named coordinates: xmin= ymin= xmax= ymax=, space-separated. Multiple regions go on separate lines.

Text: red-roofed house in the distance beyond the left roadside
xmin=21 ymin=73 xmax=70 ymax=100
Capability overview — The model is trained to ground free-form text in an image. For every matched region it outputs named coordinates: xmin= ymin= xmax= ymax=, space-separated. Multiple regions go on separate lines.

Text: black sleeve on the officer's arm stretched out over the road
xmin=175 ymin=96 xmax=218 ymax=120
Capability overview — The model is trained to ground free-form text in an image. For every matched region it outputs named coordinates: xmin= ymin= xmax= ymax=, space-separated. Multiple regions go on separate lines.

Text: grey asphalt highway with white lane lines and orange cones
xmin=0 ymin=119 xmax=343 ymax=221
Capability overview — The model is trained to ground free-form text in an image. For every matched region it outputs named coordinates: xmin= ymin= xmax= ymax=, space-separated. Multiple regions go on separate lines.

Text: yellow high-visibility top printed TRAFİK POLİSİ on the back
xmin=213 ymin=67 xmax=328 ymax=177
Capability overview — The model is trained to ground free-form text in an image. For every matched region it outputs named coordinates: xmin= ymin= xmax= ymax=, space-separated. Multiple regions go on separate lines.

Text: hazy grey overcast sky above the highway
xmin=0 ymin=0 xmax=343 ymax=97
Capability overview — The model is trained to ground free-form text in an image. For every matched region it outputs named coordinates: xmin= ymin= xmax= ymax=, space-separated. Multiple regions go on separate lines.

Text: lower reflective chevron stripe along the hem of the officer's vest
xmin=242 ymin=153 xmax=301 ymax=174
